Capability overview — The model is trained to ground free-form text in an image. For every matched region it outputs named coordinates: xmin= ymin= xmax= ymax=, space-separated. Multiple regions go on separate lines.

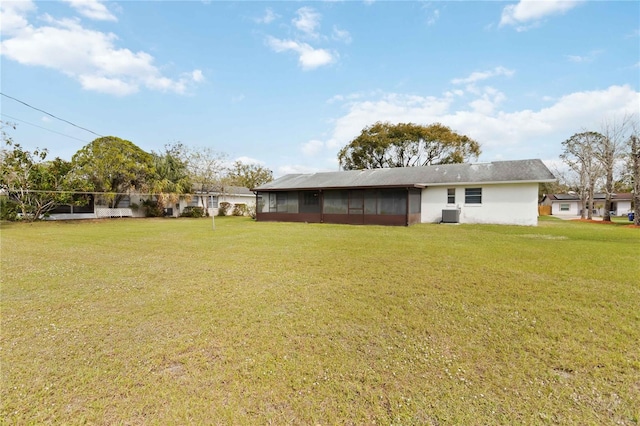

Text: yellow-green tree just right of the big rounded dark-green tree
xmin=150 ymin=142 xmax=192 ymax=208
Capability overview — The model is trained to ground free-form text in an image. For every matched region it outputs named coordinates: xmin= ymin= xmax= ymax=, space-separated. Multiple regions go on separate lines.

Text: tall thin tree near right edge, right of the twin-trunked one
xmin=594 ymin=114 xmax=632 ymax=222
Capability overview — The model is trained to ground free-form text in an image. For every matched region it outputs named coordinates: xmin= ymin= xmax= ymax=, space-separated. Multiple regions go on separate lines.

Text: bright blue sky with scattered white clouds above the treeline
xmin=0 ymin=0 xmax=640 ymax=177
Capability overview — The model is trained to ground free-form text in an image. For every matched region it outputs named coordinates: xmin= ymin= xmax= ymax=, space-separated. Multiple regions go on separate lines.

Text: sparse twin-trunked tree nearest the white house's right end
xmin=560 ymin=132 xmax=605 ymax=219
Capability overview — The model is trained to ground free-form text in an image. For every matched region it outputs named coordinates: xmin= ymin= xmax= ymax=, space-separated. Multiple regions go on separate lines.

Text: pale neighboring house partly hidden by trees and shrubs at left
xmin=48 ymin=186 xmax=255 ymax=220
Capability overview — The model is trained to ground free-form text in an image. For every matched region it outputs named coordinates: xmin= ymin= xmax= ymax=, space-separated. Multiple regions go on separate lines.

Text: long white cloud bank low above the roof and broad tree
xmin=317 ymin=85 xmax=640 ymax=160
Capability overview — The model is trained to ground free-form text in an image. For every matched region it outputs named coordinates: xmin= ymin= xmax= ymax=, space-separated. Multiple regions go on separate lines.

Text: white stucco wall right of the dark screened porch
xmin=421 ymin=183 xmax=538 ymax=226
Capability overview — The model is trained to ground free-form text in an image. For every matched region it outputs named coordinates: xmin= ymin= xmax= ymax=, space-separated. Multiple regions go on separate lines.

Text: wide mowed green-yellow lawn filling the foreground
xmin=0 ymin=218 xmax=640 ymax=425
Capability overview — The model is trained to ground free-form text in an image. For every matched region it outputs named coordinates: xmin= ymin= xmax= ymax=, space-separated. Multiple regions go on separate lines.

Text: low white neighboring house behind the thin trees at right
xmin=540 ymin=192 xmax=633 ymax=216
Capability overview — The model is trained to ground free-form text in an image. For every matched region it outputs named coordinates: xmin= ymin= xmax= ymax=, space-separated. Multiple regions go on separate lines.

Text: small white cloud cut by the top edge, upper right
xmin=500 ymin=0 xmax=581 ymax=31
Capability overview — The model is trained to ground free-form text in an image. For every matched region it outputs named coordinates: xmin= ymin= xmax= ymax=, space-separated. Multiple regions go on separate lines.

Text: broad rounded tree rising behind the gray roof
xmin=338 ymin=122 xmax=480 ymax=170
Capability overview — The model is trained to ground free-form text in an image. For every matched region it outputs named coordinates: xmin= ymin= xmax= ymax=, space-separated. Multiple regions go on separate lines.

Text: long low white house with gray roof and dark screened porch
xmin=254 ymin=160 xmax=556 ymax=226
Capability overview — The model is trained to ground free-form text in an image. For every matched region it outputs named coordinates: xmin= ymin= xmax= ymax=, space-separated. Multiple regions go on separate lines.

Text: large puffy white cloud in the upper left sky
xmin=0 ymin=3 xmax=204 ymax=96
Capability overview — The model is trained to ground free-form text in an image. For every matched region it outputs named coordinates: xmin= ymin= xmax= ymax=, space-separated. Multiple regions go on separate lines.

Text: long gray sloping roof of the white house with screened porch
xmin=254 ymin=160 xmax=556 ymax=191
